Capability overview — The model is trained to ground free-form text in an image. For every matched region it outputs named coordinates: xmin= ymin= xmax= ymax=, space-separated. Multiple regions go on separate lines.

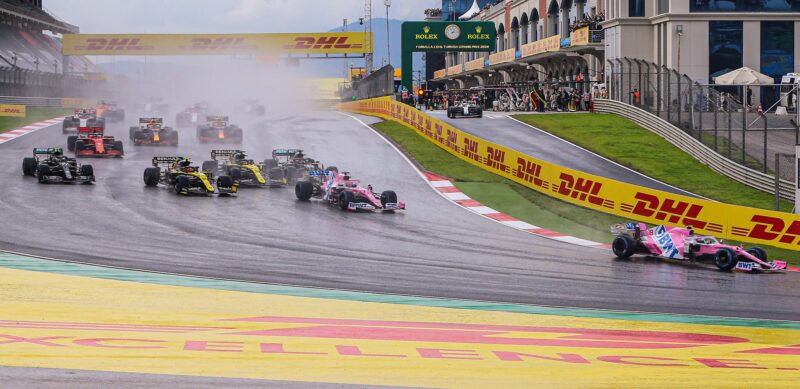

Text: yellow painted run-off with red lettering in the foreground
xmin=0 ymin=269 xmax=800 ymax=388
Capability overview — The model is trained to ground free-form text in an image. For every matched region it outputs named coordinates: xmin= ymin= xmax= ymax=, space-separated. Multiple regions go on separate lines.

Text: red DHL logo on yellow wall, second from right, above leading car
xmin=621 ymin=192 xmax=722 ymax=233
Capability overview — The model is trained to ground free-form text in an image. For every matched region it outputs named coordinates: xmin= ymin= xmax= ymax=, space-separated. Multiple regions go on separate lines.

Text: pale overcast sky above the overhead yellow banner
xmin=43 ymin=0 xmax=441 ymax=34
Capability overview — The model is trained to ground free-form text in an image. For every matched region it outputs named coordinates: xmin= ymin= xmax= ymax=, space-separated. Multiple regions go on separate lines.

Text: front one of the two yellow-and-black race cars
xmin=144 ymin=157 xmax=239 ymax=195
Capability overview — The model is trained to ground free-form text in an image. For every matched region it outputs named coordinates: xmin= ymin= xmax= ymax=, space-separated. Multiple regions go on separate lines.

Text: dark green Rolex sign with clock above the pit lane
xmin=402 ymin=22 xmax=497 ymax=52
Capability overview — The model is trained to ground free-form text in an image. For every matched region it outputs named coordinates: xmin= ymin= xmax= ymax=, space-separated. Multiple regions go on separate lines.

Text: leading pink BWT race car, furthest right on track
xmin=611 ymin=223 xmax=786 ymax=272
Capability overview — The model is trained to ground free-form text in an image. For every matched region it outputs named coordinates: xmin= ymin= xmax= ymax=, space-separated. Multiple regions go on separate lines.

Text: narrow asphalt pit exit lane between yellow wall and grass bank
xmin=434 ymin=111 xmax=697 ymax=197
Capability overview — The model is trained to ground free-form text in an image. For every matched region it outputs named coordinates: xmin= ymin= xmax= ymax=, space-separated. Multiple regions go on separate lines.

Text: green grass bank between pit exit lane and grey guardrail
xmin=515 ymin=114 xmax=792 ymax=212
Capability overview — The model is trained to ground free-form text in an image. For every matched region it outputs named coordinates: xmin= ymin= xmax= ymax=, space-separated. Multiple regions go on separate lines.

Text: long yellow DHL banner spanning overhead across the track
xmin=63 ymin=32 xmax=373 ymax=55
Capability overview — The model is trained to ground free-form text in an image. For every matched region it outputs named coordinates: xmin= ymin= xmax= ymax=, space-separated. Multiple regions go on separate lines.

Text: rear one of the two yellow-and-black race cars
xmin=203 ymin=150 xmax=288 ymax=188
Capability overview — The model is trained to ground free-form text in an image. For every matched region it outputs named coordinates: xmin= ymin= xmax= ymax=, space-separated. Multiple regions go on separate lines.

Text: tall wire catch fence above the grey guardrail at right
xmin=606 ymin=58 xmax=800 ymax=182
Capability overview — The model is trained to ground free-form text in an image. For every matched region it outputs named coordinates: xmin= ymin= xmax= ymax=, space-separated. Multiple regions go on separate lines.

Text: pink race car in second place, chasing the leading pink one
xmin=294 ymin=171 xmax=406 ymax=211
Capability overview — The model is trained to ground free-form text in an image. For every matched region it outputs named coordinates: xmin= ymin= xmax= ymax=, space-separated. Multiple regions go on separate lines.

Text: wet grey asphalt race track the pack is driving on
xmin=0 ymin=112 xmax=800 ymax=320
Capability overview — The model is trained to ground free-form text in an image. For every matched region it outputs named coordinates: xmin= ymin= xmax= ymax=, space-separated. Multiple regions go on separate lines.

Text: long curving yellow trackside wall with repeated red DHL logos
xmin=339 ymin=97 xmax=800 ymax=250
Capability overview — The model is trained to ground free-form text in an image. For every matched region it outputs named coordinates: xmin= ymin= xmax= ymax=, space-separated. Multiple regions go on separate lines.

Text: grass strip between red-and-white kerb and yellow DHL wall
xmin=372 ymin=115 xmax=800 ymax=265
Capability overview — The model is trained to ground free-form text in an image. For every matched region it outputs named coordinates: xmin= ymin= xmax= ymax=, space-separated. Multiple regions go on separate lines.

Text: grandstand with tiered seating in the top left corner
xmin=0 ymin=0 xmax=97 ymax=96
